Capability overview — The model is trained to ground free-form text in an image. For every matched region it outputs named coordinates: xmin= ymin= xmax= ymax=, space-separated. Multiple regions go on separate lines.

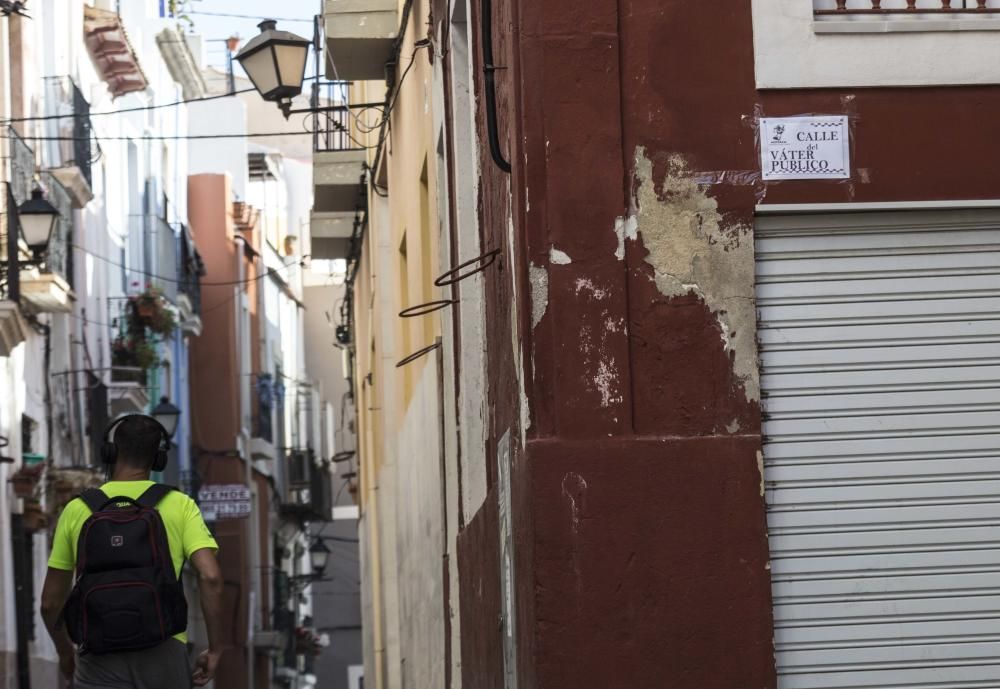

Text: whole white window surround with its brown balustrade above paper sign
xmin=751 ymin=0 xmax=1000 ymax=89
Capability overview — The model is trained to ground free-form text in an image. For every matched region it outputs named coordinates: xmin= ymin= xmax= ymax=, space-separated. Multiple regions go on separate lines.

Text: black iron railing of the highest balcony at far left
xmin=42 ymin=76 xmax=93 ymax=186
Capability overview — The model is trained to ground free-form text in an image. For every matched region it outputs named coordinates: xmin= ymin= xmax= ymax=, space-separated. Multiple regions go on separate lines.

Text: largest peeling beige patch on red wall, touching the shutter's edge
xmin=628 ymin=146 xmax=760 ymax=402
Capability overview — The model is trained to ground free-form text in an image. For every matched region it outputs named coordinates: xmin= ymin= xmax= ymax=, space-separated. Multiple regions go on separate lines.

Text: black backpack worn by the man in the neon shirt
xmin=63 ymin=484 xmax=187 ymax=653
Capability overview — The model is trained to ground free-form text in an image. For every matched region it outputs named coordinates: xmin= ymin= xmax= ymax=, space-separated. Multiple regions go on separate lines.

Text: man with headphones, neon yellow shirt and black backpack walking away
xmin=42 ymin=415 xmax=222 ymax=689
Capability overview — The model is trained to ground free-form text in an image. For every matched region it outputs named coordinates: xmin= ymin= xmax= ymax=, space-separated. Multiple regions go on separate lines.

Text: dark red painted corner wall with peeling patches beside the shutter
xmin=459 ymin=0 xmax=1000 ymax=689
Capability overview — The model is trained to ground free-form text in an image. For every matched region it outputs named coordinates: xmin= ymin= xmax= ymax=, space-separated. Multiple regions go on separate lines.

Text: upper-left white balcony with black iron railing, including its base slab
xmin=41 ymin=76 xmax=94 ymax=208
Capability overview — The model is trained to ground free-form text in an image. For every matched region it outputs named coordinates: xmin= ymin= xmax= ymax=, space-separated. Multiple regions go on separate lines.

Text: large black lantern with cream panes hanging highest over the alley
xmin=236 ymin=19 xmax=312 ymax=117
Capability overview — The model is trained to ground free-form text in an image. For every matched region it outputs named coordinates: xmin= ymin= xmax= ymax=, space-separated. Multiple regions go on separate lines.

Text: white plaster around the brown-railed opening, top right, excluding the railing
xmin=752 ymin=0 xmax=1000 ymax=89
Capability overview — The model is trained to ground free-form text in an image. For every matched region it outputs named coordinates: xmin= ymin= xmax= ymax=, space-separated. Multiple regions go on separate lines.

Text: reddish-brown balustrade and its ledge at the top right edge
xmin=813 ymin=0 xmax=1000 ymax=33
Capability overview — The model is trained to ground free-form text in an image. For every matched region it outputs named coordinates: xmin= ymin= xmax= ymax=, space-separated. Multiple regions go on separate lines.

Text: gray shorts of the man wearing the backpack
xmin=73 ymin=639 xmax=191 ymax=689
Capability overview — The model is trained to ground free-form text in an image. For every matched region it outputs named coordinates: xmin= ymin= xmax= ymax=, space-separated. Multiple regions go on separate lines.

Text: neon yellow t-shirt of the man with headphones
xmin=49 ymin=481 xmax=219 ymax=643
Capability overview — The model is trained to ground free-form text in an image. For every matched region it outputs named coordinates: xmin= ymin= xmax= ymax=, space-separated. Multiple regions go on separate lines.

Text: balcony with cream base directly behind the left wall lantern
xmin=18 ymin=171 xmax=76 ymax=313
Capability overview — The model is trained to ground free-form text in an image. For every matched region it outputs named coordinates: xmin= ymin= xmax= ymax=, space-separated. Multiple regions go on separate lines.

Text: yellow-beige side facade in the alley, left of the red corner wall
xmin=351 ymin=0 xmax=449 ymax=689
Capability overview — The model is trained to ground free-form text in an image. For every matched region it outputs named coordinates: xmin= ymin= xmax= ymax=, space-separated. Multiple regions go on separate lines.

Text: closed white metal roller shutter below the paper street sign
xmin=756 ymin=211 xmax=1000 ymax=689
